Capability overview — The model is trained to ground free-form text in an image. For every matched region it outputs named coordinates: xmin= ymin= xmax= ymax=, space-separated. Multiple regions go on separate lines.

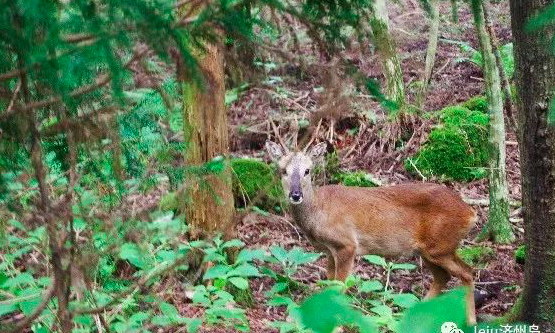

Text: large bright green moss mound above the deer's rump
xmin=405 ymin=106 xmax=488 ymax=181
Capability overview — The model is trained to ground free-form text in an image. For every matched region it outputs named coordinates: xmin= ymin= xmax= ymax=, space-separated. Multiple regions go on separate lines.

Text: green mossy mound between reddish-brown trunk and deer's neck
xmin=231 ymin=158 xmax=283 ymax=210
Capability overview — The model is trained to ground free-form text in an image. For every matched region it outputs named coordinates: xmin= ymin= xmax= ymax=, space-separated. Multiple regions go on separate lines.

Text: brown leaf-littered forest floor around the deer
xmin=190 ymin=1 xmax=523 ymax=332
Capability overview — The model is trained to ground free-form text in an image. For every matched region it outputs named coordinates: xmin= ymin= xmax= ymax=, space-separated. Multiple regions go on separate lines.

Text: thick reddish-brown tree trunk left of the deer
xmin=182 ymin=40 xmax=234 ymax=238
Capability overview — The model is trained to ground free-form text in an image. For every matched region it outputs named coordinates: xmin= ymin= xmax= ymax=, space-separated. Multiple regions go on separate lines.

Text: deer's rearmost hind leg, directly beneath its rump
xmin=433 ymin=253 xmax=476 ymax=325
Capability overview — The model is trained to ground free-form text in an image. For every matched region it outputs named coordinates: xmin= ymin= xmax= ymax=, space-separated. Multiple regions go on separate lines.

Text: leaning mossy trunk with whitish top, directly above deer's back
xmin=370 ymin=0 xmax=405 ymax=105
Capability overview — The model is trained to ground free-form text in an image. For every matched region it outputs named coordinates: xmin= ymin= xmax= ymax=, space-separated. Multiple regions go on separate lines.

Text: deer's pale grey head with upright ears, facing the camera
xmin=266 ymin=141 xmax=327 ymax=205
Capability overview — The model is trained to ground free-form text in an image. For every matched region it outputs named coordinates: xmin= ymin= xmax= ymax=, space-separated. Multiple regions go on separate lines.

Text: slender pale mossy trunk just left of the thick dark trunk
xmin=472 ymin=0 xmax=514 ymax=243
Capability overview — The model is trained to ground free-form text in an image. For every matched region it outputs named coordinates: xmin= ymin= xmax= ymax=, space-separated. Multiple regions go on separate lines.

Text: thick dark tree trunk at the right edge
xmin=510 ymin=0 xmax=555 ymax=326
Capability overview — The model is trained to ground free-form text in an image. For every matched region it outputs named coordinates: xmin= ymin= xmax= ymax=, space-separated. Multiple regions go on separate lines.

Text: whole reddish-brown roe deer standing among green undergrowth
xmin=266 ymin=141 xmax=476 ymax=324
